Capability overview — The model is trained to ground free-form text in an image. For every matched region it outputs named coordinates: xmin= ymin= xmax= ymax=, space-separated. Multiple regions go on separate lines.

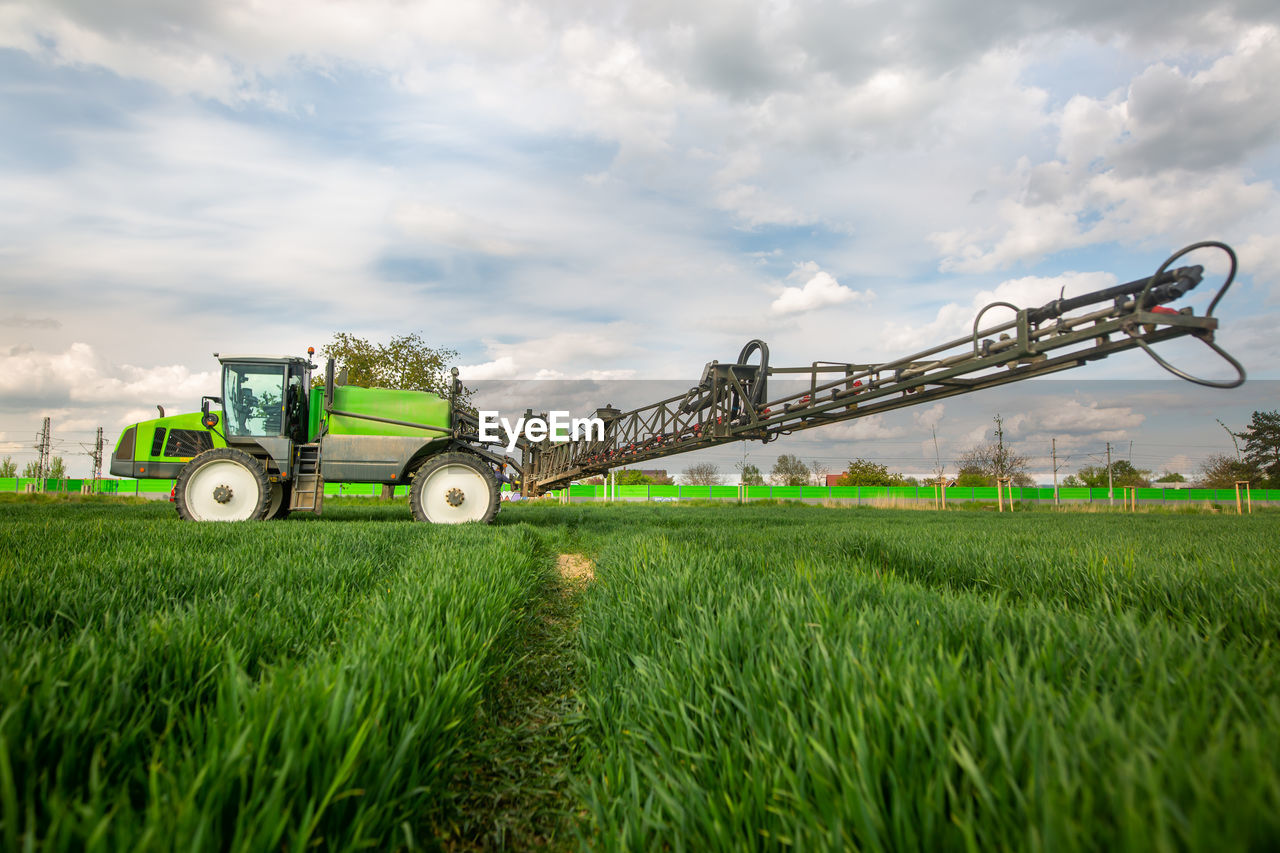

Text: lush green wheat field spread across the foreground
xmin=0 ymin=500 xmax=1280 ymax=850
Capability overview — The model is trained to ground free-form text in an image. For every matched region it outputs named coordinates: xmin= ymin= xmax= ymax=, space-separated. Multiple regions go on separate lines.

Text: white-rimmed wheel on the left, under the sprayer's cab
xmin=174 ymin=447 xmax=271 ymax=521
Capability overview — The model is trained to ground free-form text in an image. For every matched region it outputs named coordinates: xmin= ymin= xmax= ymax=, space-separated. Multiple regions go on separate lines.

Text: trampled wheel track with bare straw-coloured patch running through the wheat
xmin=438 ymin=553 xmax=595 ymax=850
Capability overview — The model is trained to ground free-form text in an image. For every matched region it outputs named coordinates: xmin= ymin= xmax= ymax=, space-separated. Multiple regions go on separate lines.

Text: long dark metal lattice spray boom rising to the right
xmin=509 ymin=242 xmax=1244 ymax=497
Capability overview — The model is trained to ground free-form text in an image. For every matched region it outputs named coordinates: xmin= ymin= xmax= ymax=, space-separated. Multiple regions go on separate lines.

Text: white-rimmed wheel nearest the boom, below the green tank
xmin=408 ymin=452 xmax=502 ymax=524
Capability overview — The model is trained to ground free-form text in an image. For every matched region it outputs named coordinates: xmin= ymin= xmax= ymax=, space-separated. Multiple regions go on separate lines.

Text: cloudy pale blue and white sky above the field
xmin=0 ymin=0 xmax=1280 ymax=473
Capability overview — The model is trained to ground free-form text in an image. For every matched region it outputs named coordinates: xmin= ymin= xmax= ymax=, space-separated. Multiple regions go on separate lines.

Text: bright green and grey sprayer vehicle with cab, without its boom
xmin=111 ymin=356 xmax=504 ymax=523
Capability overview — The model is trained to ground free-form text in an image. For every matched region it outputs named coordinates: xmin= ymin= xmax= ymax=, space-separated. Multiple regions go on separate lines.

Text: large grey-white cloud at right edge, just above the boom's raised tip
xmin=931 ymin=26 xmax=1280 ymax=273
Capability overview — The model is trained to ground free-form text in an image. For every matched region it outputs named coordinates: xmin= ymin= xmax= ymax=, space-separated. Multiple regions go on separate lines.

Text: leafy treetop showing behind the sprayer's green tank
xmin=315 ymin=332 xmax=470 ymax=398
